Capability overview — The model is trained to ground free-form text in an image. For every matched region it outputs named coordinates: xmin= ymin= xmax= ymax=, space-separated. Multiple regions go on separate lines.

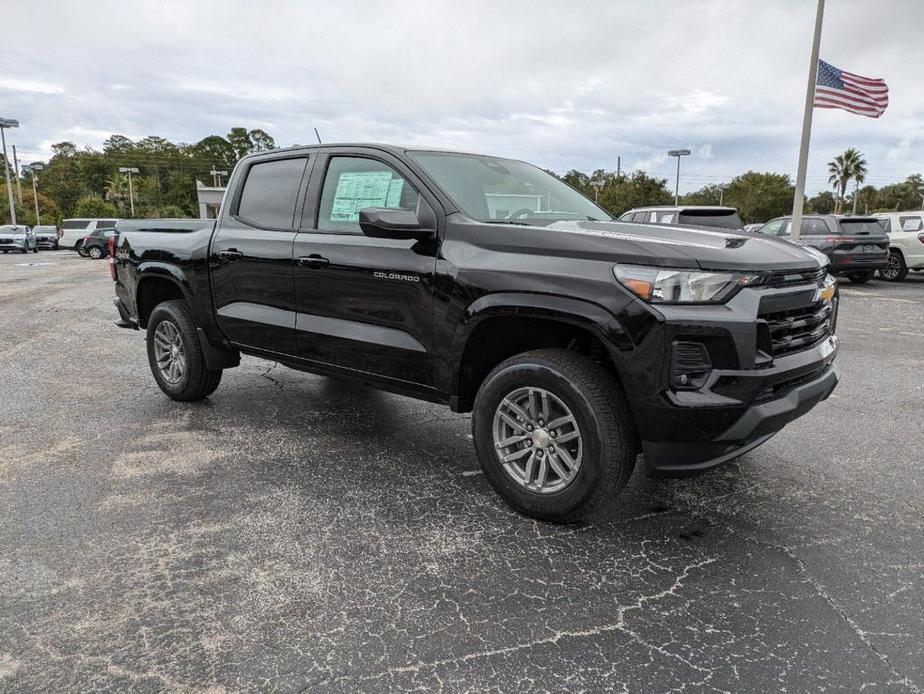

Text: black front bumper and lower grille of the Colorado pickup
xmin=613 ymin=284 xmax=839 ymax=476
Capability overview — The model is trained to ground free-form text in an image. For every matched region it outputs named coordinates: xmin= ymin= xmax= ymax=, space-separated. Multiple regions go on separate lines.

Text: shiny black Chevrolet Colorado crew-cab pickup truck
xmin=110 ymin=145 xmax=838 ymax=521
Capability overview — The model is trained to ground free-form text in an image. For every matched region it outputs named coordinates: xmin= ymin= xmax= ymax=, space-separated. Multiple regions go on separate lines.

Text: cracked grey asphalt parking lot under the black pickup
xmin=0 ymin=251 xmax=924 ymax=692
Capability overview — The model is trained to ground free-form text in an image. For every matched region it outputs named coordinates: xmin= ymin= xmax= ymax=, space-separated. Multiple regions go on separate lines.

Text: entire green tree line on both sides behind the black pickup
xmin=0 ymin=139 xmax=924 ymax=224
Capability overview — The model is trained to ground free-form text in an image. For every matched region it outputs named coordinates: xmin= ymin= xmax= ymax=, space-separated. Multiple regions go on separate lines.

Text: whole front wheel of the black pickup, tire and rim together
xmin=472 ymin=349 xmax=638 ymax=523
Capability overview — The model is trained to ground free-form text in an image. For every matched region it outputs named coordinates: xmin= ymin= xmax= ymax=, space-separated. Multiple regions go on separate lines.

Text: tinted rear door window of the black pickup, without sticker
xmin=237 ymin=157 xmax=308 ymax=231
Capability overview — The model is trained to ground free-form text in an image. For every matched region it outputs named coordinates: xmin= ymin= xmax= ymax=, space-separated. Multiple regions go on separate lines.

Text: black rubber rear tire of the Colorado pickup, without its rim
xmin=147 ymin=301 xmax=221 ymax=402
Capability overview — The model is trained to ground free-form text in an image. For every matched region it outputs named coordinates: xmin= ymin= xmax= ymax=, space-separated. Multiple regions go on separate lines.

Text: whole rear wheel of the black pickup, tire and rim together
xmin=147 ymin=301 xmax=221 ymax=402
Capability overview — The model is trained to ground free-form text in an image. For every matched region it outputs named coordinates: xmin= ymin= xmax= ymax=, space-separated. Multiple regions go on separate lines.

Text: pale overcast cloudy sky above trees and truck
xmin=7 ymin=0 xmax=924 ymax=192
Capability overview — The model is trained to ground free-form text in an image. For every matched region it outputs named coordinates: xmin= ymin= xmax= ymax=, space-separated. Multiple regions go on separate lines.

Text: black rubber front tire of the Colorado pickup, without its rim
xmin=472 ymin=349 xmax=639 ymax=523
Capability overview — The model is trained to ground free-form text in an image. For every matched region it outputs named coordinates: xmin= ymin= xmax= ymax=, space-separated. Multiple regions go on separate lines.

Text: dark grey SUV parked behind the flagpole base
xmin=757 ymin=214 xmax=889 ymax=284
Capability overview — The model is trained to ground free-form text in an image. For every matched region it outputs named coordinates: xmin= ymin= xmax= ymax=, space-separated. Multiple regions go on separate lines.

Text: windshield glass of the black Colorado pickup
xmin=409 ymin=152 xmax=612 ymax=224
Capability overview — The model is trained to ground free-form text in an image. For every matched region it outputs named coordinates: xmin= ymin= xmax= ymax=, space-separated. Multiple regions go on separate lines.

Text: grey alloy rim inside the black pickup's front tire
xmin=492 ymin=387 xmax=583 ymax=494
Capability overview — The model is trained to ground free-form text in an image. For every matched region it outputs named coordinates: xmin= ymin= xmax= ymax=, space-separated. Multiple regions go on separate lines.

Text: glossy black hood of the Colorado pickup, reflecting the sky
xmin=508 ymin=221 xmax=827 ymax=272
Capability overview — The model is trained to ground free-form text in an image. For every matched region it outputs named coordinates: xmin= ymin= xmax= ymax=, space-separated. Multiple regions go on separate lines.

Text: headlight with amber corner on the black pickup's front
xmin=613 ymin=265 xmax=760 ymax=304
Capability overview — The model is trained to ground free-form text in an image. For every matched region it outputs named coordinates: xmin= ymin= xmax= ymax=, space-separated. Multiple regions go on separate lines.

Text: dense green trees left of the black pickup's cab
xmin=0 ymin=127 xmax=276 ymax=225
